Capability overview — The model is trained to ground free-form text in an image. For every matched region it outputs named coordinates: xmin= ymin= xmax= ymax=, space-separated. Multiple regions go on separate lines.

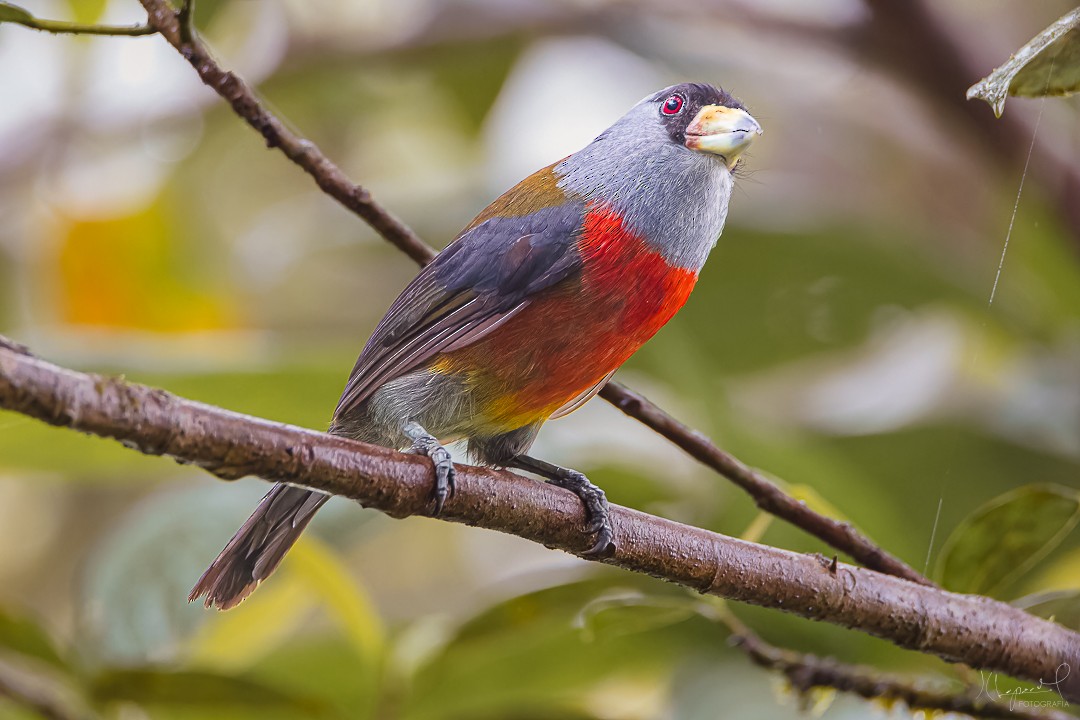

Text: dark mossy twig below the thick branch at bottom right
xmin=725 ymin=621 xmax=1076 ymax=720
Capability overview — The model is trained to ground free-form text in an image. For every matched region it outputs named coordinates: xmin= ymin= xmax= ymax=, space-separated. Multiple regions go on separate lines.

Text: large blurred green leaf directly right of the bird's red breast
xmin=652 ymin=227 xmax=984 ymax=379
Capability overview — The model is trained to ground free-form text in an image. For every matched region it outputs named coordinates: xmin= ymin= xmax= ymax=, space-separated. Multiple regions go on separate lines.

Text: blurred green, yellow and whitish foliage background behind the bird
xmin=0 ymin=0 xmax=1080 ymax=720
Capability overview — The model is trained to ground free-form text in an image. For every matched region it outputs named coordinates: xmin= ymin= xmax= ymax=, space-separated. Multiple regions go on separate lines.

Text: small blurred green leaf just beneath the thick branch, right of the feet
xmin=573 ymin=589 xmax=717 ymax=642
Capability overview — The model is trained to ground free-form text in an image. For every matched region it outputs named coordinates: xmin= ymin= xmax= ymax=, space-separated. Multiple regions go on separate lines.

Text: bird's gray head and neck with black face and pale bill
xmin=555 ymin=83 xmax=761 ymax=270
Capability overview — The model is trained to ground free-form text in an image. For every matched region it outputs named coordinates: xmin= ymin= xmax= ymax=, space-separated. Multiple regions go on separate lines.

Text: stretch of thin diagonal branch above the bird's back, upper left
xmin=141 ymin=0 xmax=435 ymax=264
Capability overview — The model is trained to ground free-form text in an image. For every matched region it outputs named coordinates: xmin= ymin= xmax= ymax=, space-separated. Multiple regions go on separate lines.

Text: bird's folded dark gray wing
xmin=334 ymin=203 xmax=584 ymax=418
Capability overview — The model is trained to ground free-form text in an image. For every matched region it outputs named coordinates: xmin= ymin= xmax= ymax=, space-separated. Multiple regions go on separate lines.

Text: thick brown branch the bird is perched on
xmin=0 ymin=338 xmax=1080 ymax=701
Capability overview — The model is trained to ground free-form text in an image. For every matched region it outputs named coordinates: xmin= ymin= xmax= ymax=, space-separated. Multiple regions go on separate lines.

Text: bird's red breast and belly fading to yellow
xmin=435 ymin=203 xmax=698 ymax=429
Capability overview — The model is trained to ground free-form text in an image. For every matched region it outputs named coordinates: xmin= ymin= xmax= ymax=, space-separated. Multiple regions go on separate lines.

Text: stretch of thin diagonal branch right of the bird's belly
xmin=599 ymin=382 xmax=933 ymax=585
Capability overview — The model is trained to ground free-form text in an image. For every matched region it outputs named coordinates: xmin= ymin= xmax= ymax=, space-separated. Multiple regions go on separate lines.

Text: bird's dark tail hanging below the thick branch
xmin=188 ymin=484 xmax=329 ymax=610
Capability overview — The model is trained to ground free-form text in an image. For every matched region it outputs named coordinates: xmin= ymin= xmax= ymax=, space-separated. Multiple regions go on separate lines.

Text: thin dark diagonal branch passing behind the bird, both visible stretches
xmin=132 ymin=0 xmax=930 ymax=584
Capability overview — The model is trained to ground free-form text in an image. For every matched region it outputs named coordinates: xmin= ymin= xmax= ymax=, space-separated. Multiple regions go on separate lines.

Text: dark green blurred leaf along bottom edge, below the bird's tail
xmin=89 ymin=669 xmax=325 ymax=715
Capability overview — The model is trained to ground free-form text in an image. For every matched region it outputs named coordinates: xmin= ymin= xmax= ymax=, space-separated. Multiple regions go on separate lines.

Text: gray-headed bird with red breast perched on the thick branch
xmin=189 ymin=82 xmax=761 ymax=610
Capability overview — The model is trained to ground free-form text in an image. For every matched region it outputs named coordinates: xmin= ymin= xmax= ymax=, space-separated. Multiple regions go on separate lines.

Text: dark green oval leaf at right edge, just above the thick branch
xmin=937 ymin=485 xmax=1080 ymax=595
